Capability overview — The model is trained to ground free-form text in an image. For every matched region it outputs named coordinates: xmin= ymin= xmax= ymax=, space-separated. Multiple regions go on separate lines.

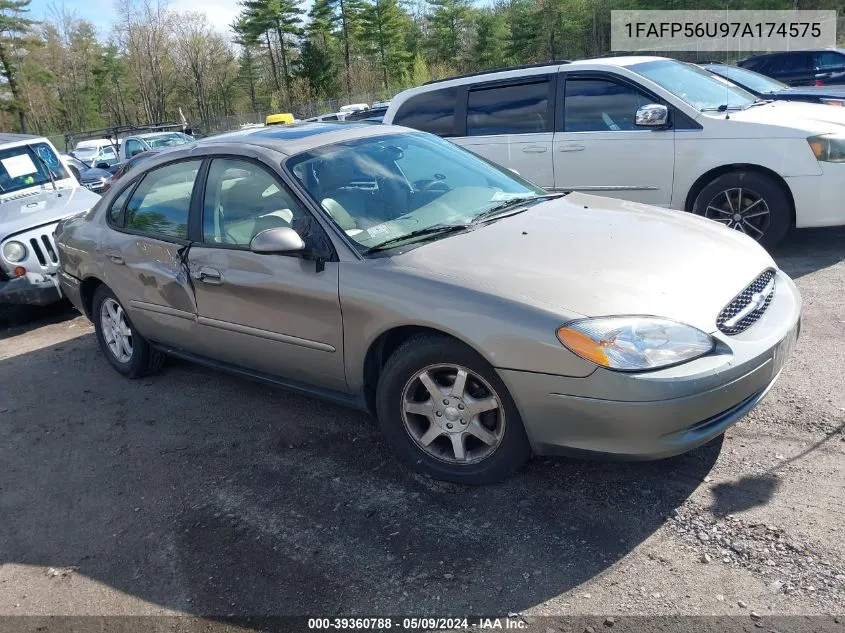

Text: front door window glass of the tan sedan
xmin=203 ymin=158 xmax=308 ymax=246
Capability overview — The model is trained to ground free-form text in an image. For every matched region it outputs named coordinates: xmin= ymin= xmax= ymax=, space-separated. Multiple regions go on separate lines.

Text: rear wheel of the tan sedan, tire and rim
xmin=91 ymin=286 xmax=164 ymax=378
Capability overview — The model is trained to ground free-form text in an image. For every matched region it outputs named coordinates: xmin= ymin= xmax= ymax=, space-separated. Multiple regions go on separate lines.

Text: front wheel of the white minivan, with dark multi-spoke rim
xmin=692 ymin=171 xmax=791 ymax=248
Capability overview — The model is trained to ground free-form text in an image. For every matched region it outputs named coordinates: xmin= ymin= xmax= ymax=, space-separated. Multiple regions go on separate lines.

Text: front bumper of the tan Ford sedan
xmin=499 ymin=272 xmax=801 ymax=459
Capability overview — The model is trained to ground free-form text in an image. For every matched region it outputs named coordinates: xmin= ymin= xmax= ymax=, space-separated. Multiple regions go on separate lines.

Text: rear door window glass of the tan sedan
xmin=124 ymin=160 xmax=202 ymax=239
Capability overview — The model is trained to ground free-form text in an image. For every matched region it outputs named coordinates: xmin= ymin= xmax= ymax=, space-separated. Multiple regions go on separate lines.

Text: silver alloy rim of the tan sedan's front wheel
xmin=402 ymin=364 xmax=506 ymax=465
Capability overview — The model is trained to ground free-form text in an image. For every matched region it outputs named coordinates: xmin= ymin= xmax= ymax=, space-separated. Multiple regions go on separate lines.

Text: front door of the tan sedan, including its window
xmin=189 ymin=158 xmax=347 ymax=391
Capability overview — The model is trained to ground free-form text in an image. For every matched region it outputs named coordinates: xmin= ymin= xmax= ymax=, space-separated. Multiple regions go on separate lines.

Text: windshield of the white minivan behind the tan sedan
xmin=629 ymin=59 xmax=756 ymax=111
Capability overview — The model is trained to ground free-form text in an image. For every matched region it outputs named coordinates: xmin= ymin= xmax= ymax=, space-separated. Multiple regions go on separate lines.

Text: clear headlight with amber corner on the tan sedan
xmin=557 ymin=316 xmax=714 ymax=371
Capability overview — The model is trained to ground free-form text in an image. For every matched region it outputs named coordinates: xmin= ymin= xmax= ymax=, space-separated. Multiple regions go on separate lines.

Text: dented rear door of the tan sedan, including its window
xmin=99 ymin=159 xmax=202 ymax=350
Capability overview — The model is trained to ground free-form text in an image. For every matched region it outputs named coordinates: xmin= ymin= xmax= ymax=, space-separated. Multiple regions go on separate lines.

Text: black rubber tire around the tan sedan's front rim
xmin=376 ymin=334 xmax=531 ymax=485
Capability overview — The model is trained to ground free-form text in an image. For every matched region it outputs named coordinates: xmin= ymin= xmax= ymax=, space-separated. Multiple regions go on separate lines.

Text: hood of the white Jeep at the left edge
xmin=0 ymin=186 xmax=100 ymax=240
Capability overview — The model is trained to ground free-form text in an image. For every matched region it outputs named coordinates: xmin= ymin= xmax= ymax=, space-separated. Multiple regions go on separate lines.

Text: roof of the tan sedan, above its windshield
xmin=196 ymin=121 xmax=413 ymax=156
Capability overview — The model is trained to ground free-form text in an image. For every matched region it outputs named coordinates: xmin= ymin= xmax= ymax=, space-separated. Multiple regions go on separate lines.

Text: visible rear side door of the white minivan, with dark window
xmin=453 ymin=74 xmax=556 ymax=188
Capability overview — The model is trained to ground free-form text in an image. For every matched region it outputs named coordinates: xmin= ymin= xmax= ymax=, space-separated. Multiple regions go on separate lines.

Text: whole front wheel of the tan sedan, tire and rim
xmin=377 ymin=335 xmax=530 ymax=485
